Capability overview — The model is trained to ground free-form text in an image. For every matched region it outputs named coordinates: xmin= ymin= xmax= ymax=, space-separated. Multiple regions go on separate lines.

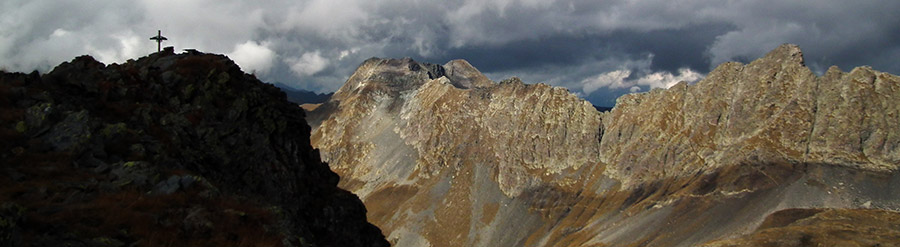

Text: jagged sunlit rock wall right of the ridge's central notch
xmin=601 ymin=45 xmax=900 ymax=187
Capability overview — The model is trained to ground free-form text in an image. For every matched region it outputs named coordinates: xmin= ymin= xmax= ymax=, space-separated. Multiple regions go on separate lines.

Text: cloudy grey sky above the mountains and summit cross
xmin=0 ymin=0 xmax=900 ymax=106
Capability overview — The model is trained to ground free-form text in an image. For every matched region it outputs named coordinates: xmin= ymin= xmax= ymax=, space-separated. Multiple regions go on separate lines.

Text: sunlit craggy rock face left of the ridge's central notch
xmin=314 ymin=59 xmax=600 ymax=196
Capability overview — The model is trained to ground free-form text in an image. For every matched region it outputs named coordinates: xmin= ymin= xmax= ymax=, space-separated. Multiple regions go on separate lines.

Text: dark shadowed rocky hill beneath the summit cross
xmin=0 ymin=49 xmax=388 ymax=246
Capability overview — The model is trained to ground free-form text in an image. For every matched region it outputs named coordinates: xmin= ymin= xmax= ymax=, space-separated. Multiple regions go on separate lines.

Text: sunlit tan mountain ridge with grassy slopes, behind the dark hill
xmin=308 ymin=45 xmax=900 ymax=246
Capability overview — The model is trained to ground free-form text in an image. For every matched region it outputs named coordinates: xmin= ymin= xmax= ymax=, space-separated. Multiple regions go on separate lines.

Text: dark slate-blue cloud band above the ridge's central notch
xmin=429 ymin=22 xmax=730 ymax=76
